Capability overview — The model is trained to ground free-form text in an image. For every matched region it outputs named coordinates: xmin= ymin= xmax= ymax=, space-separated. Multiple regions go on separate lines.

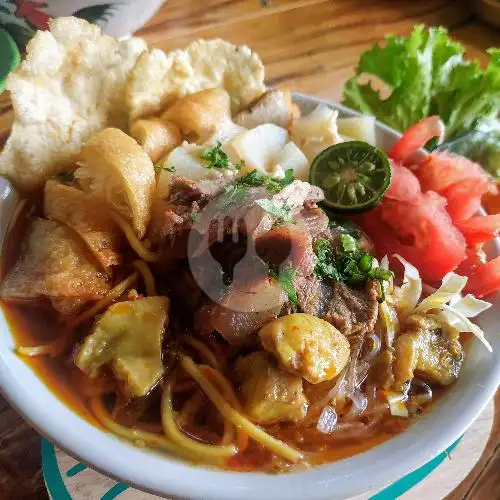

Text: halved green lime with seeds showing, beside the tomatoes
xmin=309 ymin=141 xmax=391 ymax=212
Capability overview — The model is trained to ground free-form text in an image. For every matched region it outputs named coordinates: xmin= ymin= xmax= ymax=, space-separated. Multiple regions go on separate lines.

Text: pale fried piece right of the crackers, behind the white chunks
xmin=234 ymin=89 xmax=300 ymax=129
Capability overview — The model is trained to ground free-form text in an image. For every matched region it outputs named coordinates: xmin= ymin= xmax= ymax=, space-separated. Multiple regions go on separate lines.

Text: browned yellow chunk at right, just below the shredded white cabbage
xmin=394 ymin=314 xmax=464 ymax=390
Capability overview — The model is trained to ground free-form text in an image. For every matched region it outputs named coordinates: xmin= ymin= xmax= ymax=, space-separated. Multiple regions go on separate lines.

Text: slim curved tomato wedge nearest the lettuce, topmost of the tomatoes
xmin=389 ymin=116 xmax=445 ymax=165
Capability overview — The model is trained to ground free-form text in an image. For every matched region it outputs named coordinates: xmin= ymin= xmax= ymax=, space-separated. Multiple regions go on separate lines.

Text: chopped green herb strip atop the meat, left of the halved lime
xmin=217 ymin=169 xmax=295 ymax=211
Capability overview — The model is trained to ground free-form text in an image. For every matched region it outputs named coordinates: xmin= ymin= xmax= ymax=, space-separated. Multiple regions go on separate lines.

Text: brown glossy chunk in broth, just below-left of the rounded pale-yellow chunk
xmin=235 ymin=351 xmax=308 ymax=424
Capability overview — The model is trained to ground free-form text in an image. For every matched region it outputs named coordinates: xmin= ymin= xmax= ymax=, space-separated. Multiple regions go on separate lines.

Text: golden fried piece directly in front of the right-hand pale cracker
xmin=162 ymin=89 xmax=231 ymax=142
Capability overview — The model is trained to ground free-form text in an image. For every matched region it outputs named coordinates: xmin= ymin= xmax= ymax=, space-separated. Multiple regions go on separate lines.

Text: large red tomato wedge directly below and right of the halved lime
xmin=361 ymin=192 xmax=466 ymax=284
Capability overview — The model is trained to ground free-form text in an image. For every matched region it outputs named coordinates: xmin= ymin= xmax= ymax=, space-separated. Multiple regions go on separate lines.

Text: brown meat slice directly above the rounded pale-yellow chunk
xmin=294 ymin=276 xmax=378 ymax=336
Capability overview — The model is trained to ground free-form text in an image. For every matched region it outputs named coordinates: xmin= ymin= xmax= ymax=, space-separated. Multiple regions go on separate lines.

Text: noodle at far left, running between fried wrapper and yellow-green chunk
xmin=16 ymin=271 xmax=139 ymax=358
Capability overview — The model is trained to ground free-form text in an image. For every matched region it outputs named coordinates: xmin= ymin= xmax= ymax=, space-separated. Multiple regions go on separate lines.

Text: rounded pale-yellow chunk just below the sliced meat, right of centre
xmin=259 ymin=313 xmax=350 ymax=384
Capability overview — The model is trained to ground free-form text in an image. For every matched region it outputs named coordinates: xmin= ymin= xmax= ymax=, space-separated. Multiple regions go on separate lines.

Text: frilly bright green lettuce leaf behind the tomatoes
xmin=343 ymin=25 xmax=500 ymax=141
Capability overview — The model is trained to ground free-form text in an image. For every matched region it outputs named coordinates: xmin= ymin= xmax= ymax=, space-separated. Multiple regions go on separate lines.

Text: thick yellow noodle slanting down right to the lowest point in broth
xmin=180 ymin=355 xmax=302 ymax=463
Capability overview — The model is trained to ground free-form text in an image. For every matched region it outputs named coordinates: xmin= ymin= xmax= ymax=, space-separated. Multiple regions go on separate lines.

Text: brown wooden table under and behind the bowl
xmin=0 ymin=0 xmax=500 ymax=500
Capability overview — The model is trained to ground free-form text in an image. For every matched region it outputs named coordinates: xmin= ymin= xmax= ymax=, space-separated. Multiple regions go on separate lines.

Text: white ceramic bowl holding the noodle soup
xmin=0 ymin=95 xmax=500 ymax=500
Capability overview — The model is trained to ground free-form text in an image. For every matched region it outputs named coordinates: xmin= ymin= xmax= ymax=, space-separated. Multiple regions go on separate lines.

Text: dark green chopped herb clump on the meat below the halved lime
xmin=314 ymin=234 xmax=393 ymax=294
